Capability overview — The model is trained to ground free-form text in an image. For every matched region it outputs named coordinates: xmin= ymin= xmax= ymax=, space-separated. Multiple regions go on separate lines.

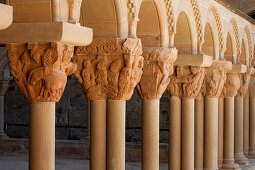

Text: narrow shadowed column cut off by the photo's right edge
xmin=248 ymin=76 xmax=255 ymax=159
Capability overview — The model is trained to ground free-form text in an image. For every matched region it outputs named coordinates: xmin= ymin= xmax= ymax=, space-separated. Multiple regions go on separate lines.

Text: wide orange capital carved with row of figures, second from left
xmin=73 ymin=38 xmax=143 ymax=100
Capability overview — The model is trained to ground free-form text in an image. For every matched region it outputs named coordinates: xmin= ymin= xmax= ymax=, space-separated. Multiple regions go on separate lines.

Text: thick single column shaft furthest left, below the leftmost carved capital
xmin=29 ymin=102 xmax=55 ymax=170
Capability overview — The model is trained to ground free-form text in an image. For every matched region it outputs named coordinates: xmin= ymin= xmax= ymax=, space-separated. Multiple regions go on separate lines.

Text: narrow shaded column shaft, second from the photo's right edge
xmin=243 ymin=93 xmax=250 ymax=156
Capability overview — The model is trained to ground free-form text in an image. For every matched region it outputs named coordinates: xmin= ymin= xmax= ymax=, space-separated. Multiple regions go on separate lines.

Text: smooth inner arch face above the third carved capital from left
xmin=137 ymin=0 xmax=169 ymax=47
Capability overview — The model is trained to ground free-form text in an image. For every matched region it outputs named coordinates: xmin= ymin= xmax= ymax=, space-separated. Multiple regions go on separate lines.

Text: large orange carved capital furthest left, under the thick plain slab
xmin=7 ymin=43 xmax=76 ymax=102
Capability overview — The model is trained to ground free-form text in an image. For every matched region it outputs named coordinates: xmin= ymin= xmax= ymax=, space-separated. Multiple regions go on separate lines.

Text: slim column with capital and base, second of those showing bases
xmin=234 ymin=73 xmax=250 ymax=165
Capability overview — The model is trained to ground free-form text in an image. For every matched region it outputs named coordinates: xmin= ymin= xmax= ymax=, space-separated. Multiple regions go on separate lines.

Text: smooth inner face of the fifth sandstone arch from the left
xmin=202 ymin=22 xmax=216 ymax=59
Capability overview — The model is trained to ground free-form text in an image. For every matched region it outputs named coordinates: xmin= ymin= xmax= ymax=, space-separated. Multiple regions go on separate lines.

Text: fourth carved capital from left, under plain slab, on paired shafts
xmin=167 ymin=66 xmax=205 ymax=98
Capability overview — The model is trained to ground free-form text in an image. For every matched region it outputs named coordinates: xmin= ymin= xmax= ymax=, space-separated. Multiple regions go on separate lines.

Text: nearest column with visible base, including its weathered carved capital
xmin=222 ymin=73 xmax=240 ymax=169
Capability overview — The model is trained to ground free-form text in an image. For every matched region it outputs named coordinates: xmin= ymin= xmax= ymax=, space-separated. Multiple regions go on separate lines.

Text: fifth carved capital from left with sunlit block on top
xmin=201 ymin=60 xmax=232 ymax=98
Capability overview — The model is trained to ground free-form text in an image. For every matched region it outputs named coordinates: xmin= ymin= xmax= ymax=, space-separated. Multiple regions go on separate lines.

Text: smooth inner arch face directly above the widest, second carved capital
xmin=80 ymin=0 xmax=128 ymax=38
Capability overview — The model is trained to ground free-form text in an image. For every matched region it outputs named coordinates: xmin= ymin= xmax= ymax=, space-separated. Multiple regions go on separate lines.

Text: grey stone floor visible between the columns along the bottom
xmin=0 ymin=156 xmax=255 ymax=170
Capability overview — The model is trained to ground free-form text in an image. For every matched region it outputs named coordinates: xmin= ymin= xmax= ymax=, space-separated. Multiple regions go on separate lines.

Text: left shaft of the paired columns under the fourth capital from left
xmin=168 ymin=96 xmax=181 ymax=170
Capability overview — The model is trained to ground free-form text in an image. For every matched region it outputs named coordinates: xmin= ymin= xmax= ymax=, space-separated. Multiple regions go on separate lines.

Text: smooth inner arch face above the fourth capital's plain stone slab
xmin=174 ymin=11 xmax=194 ymax=54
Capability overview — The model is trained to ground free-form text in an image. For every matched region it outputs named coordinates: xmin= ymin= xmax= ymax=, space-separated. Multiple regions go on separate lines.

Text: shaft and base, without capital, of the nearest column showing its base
xmin=222 ymin=97 xmax=239 ymax=169
